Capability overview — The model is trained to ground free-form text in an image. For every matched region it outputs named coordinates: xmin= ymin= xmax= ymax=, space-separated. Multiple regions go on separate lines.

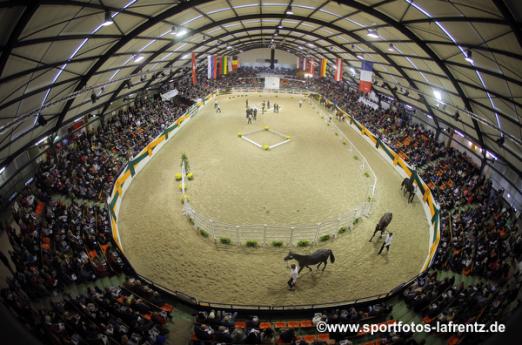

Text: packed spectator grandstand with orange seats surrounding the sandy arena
xmin=1 ymin=67 xmax=522 ymax=345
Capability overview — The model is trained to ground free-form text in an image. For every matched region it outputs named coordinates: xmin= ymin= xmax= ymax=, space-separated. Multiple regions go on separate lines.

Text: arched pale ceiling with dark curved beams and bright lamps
xmin=0 ymin=0 xmax=522 ymax=176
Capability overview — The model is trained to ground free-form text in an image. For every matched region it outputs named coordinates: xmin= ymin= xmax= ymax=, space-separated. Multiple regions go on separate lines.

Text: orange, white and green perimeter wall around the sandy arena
xmin=107 ymin=88 xmax=440 ymax=311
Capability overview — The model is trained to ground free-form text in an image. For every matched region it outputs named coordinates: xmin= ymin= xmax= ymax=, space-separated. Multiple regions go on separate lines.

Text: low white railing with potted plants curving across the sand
xmin=183 ymin=92 xmax=377 ymax=246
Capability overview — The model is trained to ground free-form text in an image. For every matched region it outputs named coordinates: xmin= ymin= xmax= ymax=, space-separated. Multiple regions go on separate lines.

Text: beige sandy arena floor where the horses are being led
xmin=119 ymin=94 xmax=429 ymax=305
